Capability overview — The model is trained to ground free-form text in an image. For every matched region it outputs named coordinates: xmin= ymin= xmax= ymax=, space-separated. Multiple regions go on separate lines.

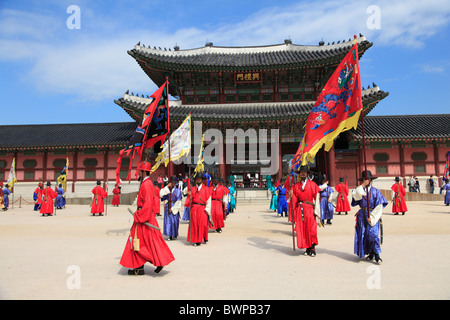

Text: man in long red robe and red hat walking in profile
xmin=120 ymin=162 xmax=175 ymax=275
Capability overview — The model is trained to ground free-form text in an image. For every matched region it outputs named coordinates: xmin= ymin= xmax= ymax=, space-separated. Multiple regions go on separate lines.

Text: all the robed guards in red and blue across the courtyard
xmin=1 ymin=162 xmax=450 ymax=275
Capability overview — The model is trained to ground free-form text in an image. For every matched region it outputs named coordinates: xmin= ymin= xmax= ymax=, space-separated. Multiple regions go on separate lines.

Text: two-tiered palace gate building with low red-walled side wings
xmin=0 ymin=35 xmax=450 ymax=200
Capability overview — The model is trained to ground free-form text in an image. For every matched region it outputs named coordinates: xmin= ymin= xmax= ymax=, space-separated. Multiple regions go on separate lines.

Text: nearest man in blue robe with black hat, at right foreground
xmin=351 ymin=170 xmax=388 ymax=263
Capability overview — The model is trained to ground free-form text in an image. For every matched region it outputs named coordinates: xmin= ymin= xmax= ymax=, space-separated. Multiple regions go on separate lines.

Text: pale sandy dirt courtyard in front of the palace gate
xmin=0 ymin=201 xmax=450 ymax=300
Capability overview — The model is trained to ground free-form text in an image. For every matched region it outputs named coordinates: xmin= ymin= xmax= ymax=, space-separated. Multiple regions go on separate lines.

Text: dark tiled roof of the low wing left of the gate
xmin=0 ymin=122 xmax=136 ymax=149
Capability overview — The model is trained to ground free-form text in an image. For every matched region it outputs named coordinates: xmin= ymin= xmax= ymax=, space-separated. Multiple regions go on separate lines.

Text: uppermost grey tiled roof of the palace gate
xmin=128 ymin=35 xmax=373 ymax=71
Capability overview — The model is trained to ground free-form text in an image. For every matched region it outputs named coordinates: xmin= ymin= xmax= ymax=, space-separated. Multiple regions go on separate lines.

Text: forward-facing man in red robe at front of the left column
xmin=187 ymin=173 xmax=211 ymax=246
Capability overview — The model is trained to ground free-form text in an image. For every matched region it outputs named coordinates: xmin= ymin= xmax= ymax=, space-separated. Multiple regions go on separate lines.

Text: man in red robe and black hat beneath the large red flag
xmin=292 ymin=166 xmax=320 ymax=257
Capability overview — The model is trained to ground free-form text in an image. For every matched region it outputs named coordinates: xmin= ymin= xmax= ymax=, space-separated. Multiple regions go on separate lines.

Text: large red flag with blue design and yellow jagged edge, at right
xmin=300 ymin=36 xmax=362 ymax=165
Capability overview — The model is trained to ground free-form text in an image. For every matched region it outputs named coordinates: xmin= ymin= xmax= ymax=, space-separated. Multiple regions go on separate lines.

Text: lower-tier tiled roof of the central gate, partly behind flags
xmin=114 ymin=86 xmax=389 ymax=121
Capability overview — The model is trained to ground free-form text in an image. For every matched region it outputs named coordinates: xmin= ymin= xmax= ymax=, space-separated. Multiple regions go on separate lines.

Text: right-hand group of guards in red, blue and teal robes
xmin=268 ymin=166 xmax=450 ymax=263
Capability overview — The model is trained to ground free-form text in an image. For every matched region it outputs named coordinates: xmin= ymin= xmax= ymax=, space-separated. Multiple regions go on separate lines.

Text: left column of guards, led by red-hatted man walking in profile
xmin=120 ymin=162 xmax=236 ymax=275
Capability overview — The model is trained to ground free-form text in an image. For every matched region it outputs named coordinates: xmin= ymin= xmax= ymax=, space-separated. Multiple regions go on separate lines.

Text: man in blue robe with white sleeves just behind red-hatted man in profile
xmin=160 ymin=176 xmax=183 ymax=240
